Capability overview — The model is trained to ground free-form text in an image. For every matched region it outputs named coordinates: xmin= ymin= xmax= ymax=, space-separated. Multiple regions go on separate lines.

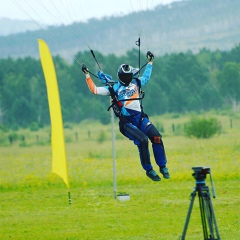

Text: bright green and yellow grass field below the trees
xmin=0 ymin=115 xmax=240 ymax=240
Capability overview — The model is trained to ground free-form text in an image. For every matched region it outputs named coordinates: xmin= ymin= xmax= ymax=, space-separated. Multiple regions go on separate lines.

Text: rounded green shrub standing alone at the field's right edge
xmin=184 ymin=118 xmax=221 ymax=138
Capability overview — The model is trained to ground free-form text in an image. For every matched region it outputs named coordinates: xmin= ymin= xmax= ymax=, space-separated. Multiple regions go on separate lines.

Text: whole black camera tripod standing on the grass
xmin=180 ymin=167 xmax=220 ymax=240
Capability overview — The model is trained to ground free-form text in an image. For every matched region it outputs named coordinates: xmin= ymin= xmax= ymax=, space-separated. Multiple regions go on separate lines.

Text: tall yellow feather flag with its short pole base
xmin=38 ymin=39 xmax=71 ymax=204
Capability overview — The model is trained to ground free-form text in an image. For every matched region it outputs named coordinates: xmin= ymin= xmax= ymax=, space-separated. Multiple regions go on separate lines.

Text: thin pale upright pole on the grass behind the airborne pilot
xmin=110 ymin=98 xmax=117 ymax=199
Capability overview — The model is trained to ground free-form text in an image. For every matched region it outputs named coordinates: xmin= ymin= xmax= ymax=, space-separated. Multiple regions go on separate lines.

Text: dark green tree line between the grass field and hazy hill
xmin=0 ymin=44 xmax=240 ymax=128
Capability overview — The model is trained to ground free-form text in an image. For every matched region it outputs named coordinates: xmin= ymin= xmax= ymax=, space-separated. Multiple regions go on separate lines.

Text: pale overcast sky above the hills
xmin=0 ymin=0 xmax=180 ymax=25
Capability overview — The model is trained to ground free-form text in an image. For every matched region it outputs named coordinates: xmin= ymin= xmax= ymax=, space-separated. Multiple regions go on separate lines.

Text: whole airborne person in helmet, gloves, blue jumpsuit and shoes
xmin=82 ymin=51 xmax=170 ymax=181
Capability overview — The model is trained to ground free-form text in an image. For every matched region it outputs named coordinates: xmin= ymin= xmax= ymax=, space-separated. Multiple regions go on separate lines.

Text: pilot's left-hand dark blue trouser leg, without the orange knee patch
xmin=120 ymin=123 xmax=153 ymax=171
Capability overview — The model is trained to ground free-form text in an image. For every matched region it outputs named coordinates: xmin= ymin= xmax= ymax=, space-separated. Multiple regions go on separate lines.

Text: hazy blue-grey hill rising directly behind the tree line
xmin=0 ymin=0 xmax=240 ymax=59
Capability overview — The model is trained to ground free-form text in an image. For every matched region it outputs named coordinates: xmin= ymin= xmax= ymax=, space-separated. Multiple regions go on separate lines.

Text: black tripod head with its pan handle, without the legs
xmin=192 ymin=167 xmax=216 ymax=198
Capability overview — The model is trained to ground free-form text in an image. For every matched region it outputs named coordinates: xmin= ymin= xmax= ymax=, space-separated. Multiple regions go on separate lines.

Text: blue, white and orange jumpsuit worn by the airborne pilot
xmin=86 ymin=63 xmax=167 ymax=171
